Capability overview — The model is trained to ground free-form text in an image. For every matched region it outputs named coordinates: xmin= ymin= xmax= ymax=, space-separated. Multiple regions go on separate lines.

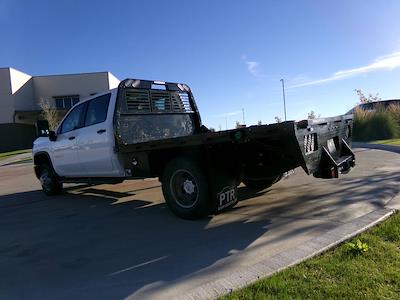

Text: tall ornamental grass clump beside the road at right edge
xmin=353 ymin=107 xmax=400 ymax=141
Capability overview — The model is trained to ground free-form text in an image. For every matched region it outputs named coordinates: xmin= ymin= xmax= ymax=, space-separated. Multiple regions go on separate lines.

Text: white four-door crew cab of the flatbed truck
xmin=33 ymin=89 xmax=124 ymax=178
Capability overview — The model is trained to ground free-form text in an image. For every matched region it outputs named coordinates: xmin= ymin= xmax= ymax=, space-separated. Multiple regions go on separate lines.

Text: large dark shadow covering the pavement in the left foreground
xmin=0 ymin=187 xmax=268 ymax=299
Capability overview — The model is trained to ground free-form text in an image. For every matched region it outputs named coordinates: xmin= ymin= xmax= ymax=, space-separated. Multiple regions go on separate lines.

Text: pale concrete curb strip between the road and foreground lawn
xmin=179 ymin=206 xmax=400 ymax=299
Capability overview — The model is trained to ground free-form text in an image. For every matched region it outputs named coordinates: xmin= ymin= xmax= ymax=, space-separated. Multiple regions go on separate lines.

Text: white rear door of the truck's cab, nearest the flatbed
xmin=77 ymin=93 xmax=115 ymax=177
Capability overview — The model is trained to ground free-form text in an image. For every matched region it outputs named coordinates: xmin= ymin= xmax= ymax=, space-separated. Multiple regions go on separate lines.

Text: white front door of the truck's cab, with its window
xmin=51 ymin=104 xmax=85 ymax=177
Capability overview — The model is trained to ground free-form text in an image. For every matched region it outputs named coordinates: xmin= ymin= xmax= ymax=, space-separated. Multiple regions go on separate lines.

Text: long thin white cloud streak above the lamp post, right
xmin=288 ymin=52 xmax=400 ymax=88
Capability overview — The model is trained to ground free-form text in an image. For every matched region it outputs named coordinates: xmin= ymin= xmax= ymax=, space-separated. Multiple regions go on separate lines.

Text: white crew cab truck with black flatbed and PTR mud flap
xmin=33 ymin=79 xmax=355 ymax=219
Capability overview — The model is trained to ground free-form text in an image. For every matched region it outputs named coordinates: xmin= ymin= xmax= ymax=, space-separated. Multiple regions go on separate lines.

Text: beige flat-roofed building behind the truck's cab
xmin=0 ymin=68 xmax=119 ymax=152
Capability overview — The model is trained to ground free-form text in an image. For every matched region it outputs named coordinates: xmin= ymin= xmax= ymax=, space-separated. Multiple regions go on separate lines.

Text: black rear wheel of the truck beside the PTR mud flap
xmin=161 ymin=158 xmax=210 ymax=220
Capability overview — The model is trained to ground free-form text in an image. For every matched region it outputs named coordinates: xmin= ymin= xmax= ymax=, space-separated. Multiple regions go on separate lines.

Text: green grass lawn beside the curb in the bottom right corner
xmin=222 ymin=213 xmax=400 ymax=299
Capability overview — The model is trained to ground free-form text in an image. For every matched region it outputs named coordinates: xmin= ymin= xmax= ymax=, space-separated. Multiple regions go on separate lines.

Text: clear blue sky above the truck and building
xmin=0 ymin=0 xmax=400 ymax=129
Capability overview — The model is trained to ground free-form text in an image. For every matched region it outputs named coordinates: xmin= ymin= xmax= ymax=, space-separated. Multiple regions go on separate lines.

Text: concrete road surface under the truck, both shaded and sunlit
xmin=0 ymin=149 xmax=400 ymax=299
